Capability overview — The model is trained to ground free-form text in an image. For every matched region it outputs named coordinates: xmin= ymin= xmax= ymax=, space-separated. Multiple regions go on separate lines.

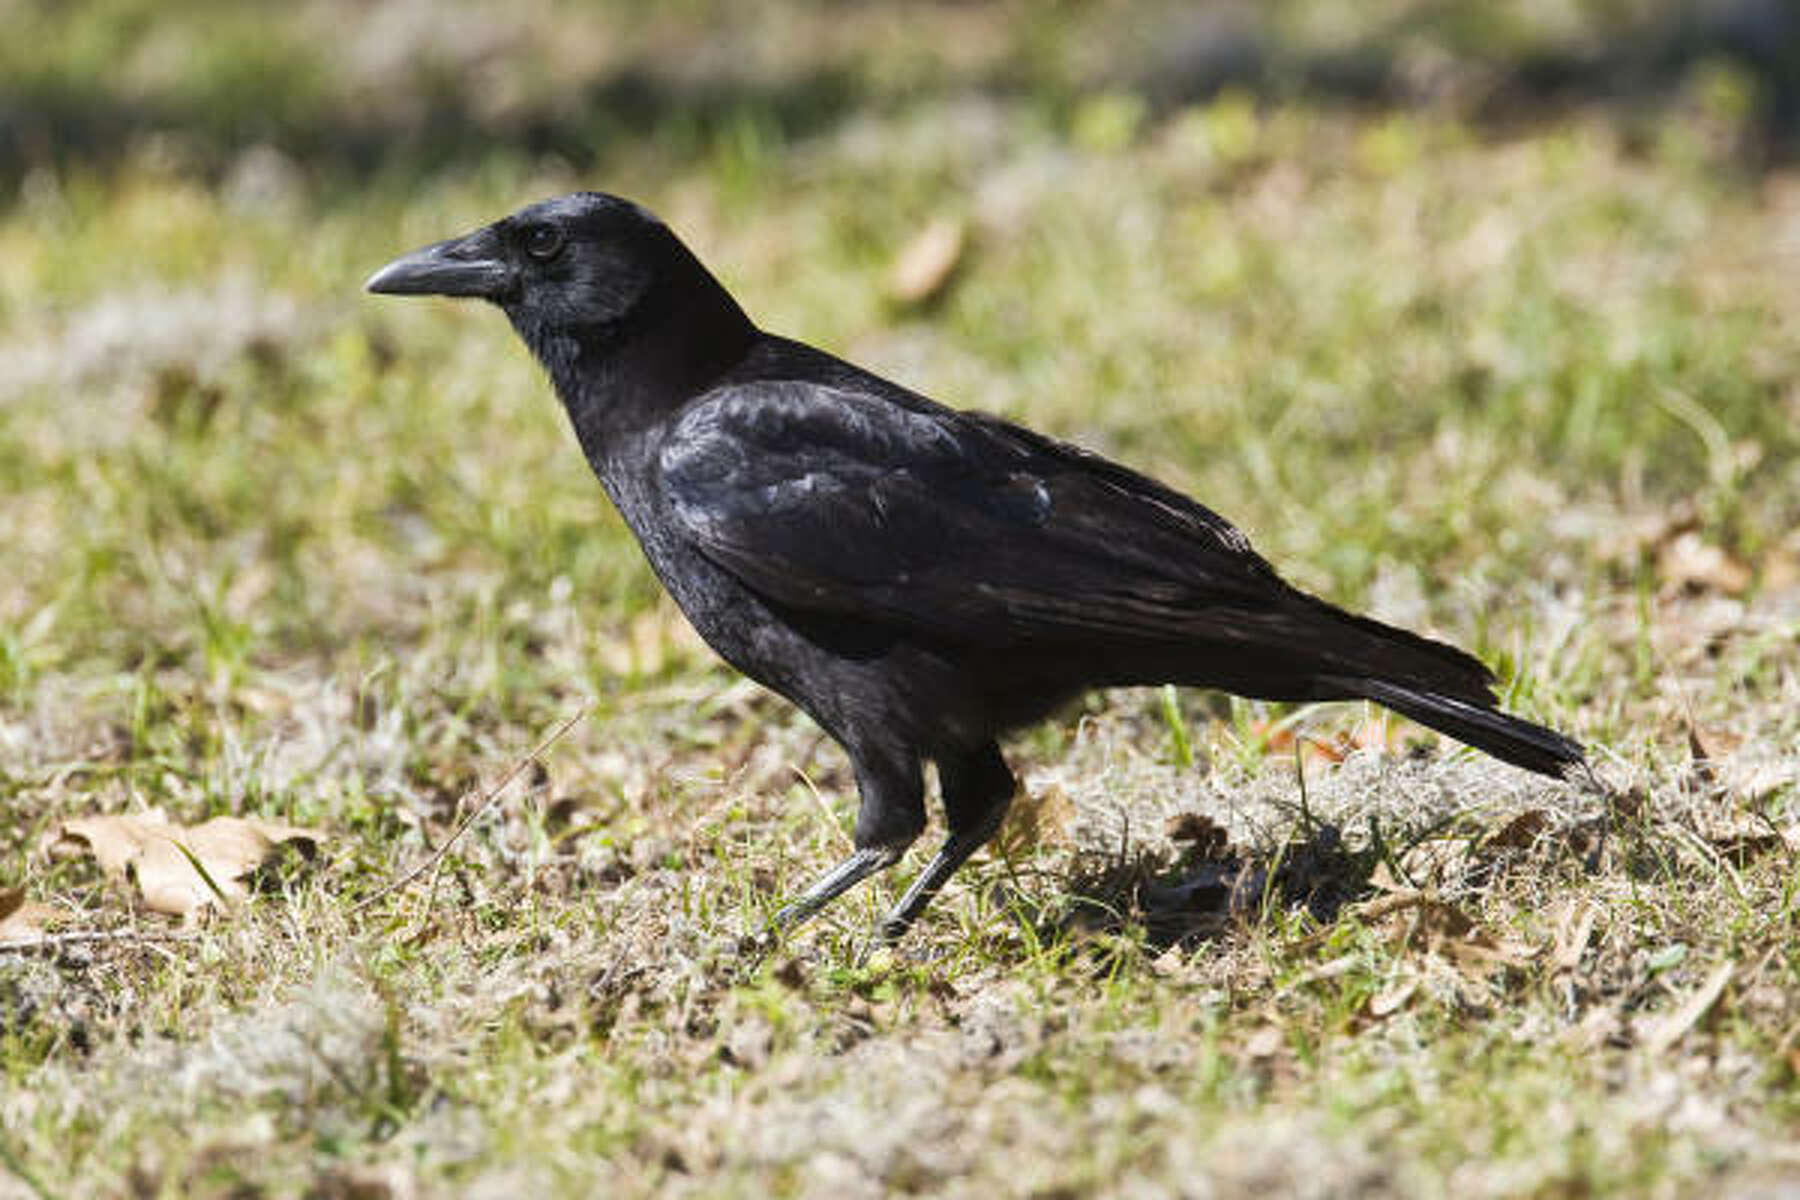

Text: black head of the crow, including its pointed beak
xmin=365 ymin=193 xmax=752 ymax=398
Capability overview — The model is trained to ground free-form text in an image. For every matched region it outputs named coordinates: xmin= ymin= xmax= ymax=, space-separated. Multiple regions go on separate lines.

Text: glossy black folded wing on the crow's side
xmin=659 ymin=381 xmax=1292 ymax=646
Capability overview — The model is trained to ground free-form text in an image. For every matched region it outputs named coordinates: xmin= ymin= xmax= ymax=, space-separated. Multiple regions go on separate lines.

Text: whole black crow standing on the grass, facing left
xmin=367 ymin=193 xmax=1584 ymax=937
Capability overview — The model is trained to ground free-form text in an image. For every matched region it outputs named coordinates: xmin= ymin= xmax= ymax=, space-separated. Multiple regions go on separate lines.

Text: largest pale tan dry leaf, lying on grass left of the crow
xmin=52 ymin=817 xmax=320 ymax=918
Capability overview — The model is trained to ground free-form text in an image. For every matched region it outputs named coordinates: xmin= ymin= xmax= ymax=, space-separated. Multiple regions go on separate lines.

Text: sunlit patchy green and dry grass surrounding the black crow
xmin=0 ymin=4 xmax=1800 ymax=1196
